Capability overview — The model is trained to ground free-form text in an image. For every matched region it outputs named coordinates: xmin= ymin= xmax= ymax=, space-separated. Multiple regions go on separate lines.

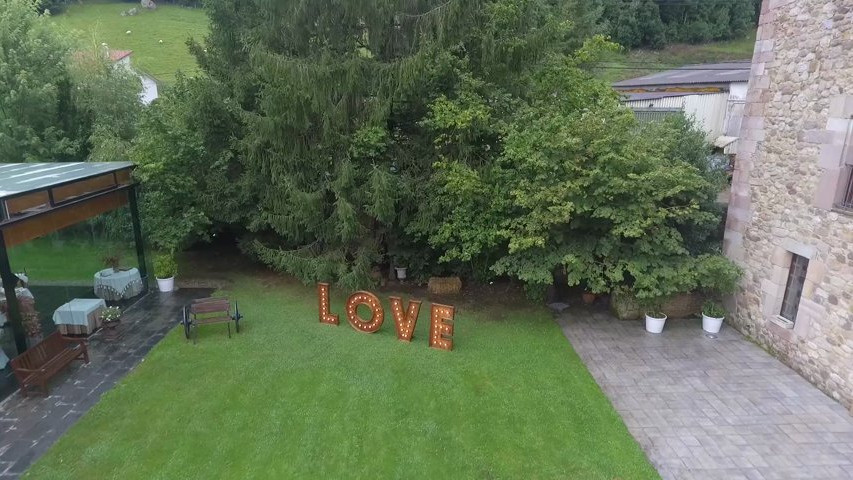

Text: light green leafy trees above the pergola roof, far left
xmin=0 ymin=0 xmax=140 ymax=162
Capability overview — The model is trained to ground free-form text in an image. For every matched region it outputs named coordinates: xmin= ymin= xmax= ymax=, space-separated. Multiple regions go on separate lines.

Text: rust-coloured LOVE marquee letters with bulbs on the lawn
xmin=317 ymin=283 xmax=456 ymax=350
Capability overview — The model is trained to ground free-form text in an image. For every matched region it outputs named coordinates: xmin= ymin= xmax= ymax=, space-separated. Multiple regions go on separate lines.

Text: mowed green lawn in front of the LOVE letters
xmin=24 ymin=278 xmax=658 ymax=480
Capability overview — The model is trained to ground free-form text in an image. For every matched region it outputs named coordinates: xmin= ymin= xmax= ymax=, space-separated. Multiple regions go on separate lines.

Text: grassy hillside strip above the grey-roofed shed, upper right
xmin=596 ymin=33 xmax=755 ymax=82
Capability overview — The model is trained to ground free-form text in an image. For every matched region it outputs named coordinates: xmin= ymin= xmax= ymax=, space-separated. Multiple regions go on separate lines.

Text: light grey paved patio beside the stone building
xmin=557 ymin=309 xmax=853 ymax=480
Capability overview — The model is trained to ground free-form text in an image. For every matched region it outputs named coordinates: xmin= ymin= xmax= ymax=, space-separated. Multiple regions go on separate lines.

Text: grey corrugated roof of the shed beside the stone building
xmin=613 ymin=60 xmax=752 ymax=89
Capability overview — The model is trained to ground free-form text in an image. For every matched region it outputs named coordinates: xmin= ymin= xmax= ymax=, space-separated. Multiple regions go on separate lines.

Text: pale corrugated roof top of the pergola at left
xmin=0 ymin=162 xmax=133 ymax=199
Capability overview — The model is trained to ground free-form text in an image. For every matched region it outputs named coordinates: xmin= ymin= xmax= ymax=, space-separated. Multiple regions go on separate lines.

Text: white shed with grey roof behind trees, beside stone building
xmin=613 ymin=61 xmax=751 ymax=155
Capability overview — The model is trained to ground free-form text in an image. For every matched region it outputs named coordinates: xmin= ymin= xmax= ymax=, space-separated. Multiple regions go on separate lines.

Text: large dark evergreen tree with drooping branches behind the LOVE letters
xmin=164 ymin=0 xmax=592 ymax=287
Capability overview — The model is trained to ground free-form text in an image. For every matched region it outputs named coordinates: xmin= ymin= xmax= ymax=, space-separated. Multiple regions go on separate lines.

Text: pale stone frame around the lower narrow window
xmin=761 ymin=238 xmax=826 ymax=341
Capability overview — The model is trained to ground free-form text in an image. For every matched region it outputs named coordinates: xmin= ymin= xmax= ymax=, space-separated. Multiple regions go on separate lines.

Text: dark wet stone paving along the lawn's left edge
xmin=0 ymin=289 xmax=212 ymax=480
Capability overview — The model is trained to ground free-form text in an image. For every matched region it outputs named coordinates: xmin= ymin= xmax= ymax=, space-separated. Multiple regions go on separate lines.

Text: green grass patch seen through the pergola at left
xmin=9 ymin=236 xmax=137 ymax=285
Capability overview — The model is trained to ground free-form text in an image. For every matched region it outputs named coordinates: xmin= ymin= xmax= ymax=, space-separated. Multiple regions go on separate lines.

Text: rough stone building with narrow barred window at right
xmin=725 ymin=0 xmax=853 ymax=408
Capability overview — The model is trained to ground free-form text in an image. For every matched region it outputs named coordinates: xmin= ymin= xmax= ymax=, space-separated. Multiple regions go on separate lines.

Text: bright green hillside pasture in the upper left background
xmin=53 ymin=0 xmax=208 ymax=84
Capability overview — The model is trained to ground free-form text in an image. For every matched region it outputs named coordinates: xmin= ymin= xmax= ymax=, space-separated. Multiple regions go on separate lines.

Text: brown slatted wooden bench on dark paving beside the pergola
xmin=11 ymin=332 xmax=89 ymax=397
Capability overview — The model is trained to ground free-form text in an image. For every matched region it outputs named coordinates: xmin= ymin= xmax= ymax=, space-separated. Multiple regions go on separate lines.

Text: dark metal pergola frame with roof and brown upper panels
xmin=0 ymin=162 xmax=148 ymax=354
